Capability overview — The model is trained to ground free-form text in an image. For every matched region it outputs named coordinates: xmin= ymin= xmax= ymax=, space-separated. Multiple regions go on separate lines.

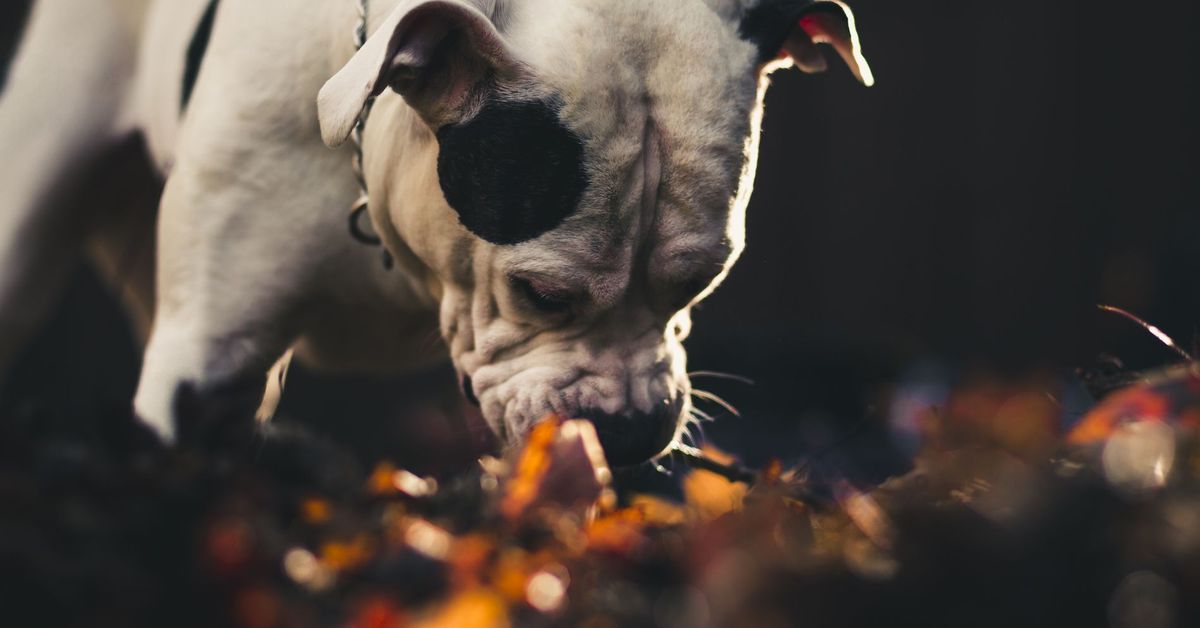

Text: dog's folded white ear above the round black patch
xmin=317 ymin=0 xmax=517 ymax=146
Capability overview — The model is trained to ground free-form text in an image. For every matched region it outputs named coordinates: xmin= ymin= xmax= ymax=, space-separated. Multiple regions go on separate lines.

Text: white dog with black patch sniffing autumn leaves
xmin=0 ymin=0 xmax=872 ymax=463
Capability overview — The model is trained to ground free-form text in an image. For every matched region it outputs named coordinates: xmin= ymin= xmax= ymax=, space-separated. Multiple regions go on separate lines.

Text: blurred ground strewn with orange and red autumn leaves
xmin=0 ymin=365 xmax=1200 ymax=628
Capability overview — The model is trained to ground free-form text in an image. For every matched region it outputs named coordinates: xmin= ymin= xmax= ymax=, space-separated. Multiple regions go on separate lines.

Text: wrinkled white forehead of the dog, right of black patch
xmin=494 ymin=0 xmax=757 ymax=249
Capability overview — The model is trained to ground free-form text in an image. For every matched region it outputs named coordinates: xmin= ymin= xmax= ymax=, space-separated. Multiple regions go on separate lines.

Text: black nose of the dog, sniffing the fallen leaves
xmin=580 ymin=400 xmax=679 ymax=467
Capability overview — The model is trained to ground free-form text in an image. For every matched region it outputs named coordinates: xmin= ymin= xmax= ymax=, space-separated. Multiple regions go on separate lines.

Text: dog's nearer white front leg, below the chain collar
xmin=134 ymin=138 xmax=355 ymax=441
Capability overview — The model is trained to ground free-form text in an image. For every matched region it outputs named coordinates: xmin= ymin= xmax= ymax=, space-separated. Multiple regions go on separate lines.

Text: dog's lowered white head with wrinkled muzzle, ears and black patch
xmin=319 ymin=0 xmax=872 ymax=465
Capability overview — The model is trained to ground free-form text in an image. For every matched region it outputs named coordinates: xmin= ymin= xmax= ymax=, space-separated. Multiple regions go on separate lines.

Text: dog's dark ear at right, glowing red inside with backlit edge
xmin=738 ymin=0 xmax=875 ymax=86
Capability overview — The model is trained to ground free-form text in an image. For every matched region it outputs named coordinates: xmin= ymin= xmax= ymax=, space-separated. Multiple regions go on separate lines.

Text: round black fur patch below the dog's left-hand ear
xmin=437 ymin=101 xmax=588 ymax=245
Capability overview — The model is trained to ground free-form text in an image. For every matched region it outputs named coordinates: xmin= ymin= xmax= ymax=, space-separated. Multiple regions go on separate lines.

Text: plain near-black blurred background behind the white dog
xmin=0 ymin=0 xmax=1200 ymax=477
